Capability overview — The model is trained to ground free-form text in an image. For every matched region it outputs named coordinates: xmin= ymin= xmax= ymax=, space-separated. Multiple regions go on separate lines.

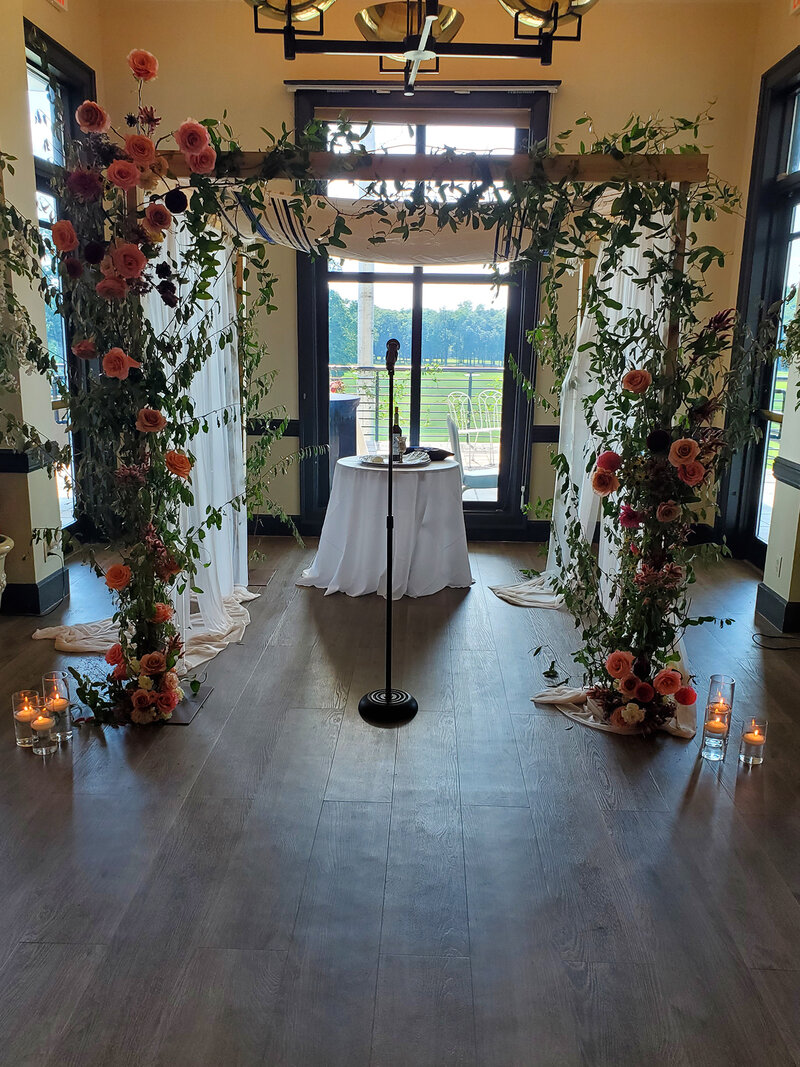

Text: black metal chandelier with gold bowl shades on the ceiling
xmin=245 ymin=0 xmax=597 ymax=96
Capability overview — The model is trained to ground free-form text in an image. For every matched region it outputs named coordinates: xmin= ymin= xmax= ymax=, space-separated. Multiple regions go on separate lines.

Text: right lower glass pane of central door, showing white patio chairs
xmin=419 ymin=282 xmax=508 ymax=501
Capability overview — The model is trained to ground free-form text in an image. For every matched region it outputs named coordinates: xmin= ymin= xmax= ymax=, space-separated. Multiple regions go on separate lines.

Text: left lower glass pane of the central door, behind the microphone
xmin=329 ymin=282 xmax=413 ymax=469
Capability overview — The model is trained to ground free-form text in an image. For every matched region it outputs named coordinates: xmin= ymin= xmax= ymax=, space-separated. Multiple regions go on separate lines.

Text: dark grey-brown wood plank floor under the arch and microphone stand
xmin=0 ymin=540 xmax=800 ymax=1067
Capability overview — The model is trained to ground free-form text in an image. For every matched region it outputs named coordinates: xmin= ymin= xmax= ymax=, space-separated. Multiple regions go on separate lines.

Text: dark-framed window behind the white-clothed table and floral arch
xmin=298 ymin=91 xmax=549 ymax=536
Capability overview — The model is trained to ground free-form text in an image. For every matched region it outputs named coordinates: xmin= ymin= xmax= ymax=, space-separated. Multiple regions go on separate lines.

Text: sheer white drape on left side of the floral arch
xmin=33 ymin=234 xmax=257 ymax=670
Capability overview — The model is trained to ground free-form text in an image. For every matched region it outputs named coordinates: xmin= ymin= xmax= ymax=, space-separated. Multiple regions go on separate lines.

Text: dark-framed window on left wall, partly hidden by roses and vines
xmin=25 ymin=22 xmax=95 ymax=528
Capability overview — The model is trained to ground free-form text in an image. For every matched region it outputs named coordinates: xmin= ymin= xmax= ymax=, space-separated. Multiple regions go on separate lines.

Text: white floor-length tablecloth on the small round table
xmin=298 ymin=457 xmax=473 ymax=600
